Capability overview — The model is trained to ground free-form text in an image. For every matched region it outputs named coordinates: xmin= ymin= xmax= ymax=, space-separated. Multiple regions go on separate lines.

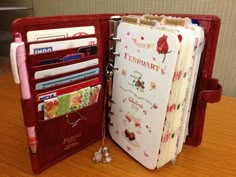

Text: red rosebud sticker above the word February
xmin=156 ymin=35 xmax=171 ymax=63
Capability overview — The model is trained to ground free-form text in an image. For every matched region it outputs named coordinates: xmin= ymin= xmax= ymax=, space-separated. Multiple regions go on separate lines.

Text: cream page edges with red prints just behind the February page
xmin=157 ymin=27 xmax=195 ymax=167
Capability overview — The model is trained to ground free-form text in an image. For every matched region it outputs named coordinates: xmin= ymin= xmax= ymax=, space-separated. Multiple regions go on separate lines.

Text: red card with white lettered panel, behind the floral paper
xmin=36 ymin=78 xmax=100 ymax=101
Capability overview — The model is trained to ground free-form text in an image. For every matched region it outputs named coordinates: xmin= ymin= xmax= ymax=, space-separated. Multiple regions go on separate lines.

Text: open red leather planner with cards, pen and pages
xmin=11 ymin=14 xmax=222 ymax=173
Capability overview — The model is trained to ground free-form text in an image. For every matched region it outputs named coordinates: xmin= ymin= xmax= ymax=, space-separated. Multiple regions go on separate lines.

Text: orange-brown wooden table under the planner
xmin=0 ymin=74 xmax=236 ymax=177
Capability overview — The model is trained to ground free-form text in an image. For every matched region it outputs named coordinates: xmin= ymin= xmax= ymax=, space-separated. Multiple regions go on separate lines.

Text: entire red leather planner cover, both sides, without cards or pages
xmin=12 ymin=14 xmax=222 ymax=173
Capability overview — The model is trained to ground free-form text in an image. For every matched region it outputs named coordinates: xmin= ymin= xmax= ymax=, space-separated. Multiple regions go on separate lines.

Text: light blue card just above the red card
xmin=35 ymin=68 xmax=99 ymax=90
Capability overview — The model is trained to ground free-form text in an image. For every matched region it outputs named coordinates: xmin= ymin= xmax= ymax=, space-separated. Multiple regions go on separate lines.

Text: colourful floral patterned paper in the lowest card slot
xmin=44 ymin=85 xmax=101 ymax=120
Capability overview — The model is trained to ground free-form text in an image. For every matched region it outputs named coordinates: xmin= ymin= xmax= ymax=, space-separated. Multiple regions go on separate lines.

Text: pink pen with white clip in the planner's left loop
xmin=11 ymin=33 xmax=37 ymax=154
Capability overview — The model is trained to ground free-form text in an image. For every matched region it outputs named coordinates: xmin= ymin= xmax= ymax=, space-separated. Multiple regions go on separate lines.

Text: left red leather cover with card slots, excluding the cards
xmin=12 ymin=15 xmax=108 ymax=173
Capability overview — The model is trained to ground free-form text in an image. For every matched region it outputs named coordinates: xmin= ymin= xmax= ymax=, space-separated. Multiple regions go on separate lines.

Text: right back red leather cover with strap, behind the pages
xmin=183 ymin=15 xmax=222 ymax=145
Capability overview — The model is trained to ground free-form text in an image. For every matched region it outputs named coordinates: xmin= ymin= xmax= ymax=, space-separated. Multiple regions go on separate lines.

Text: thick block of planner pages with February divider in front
xmin=109 ymin=16 xmax=204 ymax=169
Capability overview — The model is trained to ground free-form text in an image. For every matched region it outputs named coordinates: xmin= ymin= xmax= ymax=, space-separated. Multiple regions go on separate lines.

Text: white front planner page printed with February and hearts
xmin=109 ymin=22 xmax=180 ymax=169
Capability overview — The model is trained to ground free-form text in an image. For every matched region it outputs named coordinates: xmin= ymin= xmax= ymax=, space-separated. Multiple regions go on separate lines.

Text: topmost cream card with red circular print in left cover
xmin=27 ymin=26 xmax=95 ymax=42
